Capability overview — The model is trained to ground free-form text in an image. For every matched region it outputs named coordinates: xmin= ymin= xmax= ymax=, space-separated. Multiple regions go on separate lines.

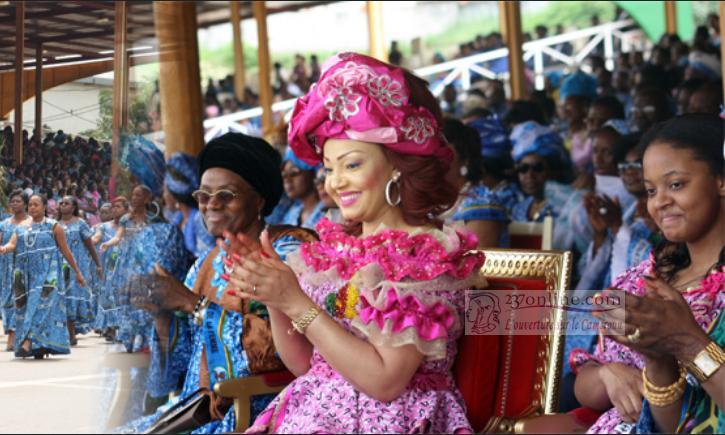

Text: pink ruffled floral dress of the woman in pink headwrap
xmin=247 ymin=219 xmax=484 ymax=433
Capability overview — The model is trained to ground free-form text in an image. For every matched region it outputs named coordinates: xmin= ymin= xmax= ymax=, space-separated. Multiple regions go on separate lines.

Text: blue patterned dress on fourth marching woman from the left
xmin=95 ymin=221 xmax=119 ymax=329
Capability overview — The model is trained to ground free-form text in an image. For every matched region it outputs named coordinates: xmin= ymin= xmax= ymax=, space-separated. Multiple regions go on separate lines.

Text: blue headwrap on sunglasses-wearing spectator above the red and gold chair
xmin=510 ymin=121 xmax=568 ymax=163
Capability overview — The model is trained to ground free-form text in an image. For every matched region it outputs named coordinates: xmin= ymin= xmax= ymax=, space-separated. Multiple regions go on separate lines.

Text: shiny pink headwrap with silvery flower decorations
xmin=288 ymin=53 xmax=453 ymax=165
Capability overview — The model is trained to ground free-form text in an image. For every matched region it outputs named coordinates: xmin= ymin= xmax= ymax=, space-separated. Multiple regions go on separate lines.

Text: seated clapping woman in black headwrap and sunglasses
xmin=122 ymin=133 xmax=314 ymax=433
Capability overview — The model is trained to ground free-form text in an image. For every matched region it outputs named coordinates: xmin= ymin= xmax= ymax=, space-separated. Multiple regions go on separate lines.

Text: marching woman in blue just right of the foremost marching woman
xmin=58 ymin=196 xmax=103 ymax=346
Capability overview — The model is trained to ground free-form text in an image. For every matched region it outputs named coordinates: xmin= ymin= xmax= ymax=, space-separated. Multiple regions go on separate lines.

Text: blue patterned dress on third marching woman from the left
xmin=59 ymin=219 xmax=99 ymax=334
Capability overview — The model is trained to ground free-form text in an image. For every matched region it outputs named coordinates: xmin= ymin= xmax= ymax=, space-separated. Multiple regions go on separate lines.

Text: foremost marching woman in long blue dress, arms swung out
xmin=3 ymin=195 xmax=86 ymax=359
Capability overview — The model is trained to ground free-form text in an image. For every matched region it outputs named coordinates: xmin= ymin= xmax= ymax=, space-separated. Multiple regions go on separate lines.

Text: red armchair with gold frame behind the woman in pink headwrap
xmin=454 ymin=249 xmax=572 ymax=433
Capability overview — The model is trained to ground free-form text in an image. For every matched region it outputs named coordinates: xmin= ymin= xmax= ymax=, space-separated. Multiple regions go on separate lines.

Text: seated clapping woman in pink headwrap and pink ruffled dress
xmin=226 ymin=53 xmax=483 ymax=433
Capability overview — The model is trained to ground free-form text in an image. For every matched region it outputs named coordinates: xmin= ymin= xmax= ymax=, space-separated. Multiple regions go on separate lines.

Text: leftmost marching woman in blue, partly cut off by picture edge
xmin=0 ymin=189 xmax=30 ymax=352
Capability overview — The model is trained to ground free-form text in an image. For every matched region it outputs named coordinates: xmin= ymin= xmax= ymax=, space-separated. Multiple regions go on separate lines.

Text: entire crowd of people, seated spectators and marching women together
xmin=0 ymin=11 xmax=725 ymax=433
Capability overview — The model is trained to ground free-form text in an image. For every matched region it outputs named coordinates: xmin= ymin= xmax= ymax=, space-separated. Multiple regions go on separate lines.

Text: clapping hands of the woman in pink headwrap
xmin=228 ymin=231 xmax=310 ymax=318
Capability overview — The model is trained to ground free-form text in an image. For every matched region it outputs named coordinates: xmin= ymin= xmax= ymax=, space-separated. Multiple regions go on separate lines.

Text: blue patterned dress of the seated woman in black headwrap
xmin=121 ymin=236 xmax=301 ymax=434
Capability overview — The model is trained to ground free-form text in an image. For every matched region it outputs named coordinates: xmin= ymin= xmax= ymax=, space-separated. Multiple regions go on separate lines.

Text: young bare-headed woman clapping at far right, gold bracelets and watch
xmin=572 ymin=114 xmax=725 ymax=433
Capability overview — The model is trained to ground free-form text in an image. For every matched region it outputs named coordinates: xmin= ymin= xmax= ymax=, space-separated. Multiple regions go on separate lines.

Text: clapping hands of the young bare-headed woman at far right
xmin=594 ymin=276 xmax=708 ymax=361
